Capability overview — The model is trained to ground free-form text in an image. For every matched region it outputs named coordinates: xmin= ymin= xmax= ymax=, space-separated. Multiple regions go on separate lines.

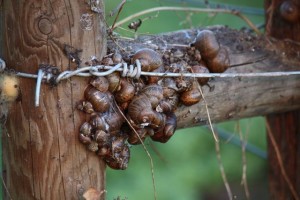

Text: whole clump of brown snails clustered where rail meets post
xmin=77 ymin=28 xmax=229 ymax=169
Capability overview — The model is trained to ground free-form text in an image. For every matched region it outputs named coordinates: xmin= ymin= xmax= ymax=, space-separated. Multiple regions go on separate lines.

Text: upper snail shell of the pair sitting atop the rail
xmin=193 ymin=30 xmax=220 ymax=60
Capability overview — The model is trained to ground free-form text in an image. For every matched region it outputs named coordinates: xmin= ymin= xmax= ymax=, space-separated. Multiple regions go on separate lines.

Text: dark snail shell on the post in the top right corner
xmin=279 ymin=0 xmax=300 ymax=23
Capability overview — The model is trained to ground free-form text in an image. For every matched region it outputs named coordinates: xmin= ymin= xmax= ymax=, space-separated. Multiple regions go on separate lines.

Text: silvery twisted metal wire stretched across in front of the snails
xmin=0 ymin=58 xmax=300 ymax=107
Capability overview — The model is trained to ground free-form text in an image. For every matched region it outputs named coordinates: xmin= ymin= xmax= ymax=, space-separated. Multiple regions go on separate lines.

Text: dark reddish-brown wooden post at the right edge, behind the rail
xmin=265 ymin=0 xmax=300 ymax=200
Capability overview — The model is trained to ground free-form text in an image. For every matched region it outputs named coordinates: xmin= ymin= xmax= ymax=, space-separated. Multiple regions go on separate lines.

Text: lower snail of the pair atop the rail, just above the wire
xmin=207 ymin=47 xmax=230 ymax=73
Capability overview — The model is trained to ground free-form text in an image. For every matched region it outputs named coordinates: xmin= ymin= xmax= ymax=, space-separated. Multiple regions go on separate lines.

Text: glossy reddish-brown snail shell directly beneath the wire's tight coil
xmin=115 ymin=78 xmax=135 ymax=103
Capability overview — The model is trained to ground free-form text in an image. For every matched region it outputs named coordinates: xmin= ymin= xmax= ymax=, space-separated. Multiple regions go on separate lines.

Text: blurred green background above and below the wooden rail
xmin=104 ymin=0 xmax=268 ymax=200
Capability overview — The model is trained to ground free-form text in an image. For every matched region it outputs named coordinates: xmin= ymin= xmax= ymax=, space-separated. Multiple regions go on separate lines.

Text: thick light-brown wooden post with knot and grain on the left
xmin=0 ymin=0 xmax=106 ymax=200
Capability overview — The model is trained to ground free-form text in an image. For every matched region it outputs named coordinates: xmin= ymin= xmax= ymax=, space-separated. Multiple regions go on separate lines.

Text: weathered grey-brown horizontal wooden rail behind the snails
xmin=108 ymin=26 xmax=300 ymax=128
